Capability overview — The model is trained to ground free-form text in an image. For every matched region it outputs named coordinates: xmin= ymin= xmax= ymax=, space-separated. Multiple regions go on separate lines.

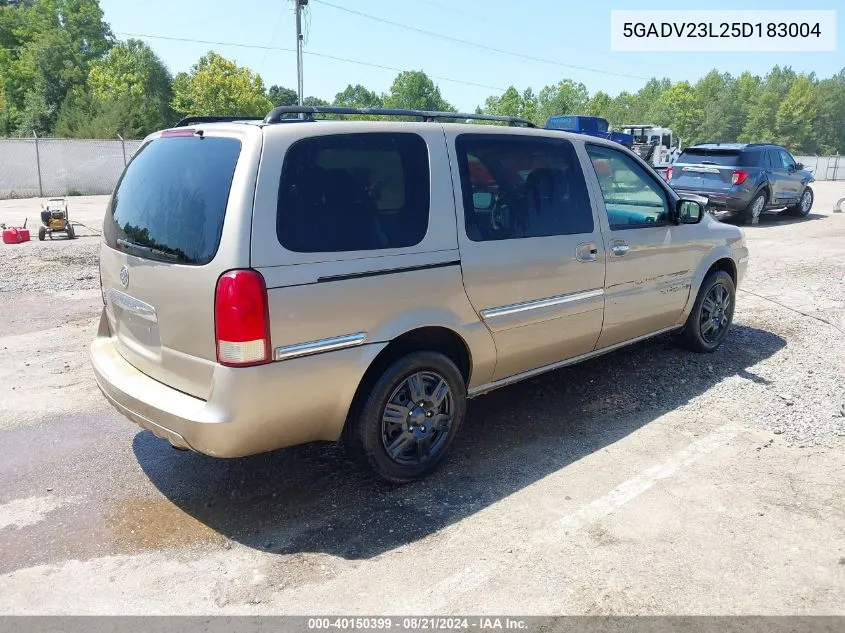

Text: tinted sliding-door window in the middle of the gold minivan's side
xmin=456 ymin=134 xmax=593 ymax=242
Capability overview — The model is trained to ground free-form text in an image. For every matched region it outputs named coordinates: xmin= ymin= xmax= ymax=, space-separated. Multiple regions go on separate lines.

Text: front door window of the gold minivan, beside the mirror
xmin=587 ymin=145 xmax=669 ymax=231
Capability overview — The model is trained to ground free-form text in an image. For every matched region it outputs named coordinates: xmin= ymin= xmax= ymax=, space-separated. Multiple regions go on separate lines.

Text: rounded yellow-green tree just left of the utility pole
xmin=172 ymin=51 xmax=273 ymax=116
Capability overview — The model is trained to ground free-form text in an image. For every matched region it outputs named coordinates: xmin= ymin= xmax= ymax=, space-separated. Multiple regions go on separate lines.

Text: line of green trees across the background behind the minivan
xmin=0 ymin=0 xmax=845 ymax=153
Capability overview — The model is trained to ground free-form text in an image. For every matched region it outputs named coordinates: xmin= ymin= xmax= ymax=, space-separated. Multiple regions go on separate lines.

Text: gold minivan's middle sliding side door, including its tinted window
xmin=446 ymin=129 xmax=605 ymax=380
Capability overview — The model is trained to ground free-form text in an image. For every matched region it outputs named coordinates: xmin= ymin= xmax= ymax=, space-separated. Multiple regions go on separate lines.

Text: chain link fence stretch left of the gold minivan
xmin=0 ymin=137 xmax=141 ymax=199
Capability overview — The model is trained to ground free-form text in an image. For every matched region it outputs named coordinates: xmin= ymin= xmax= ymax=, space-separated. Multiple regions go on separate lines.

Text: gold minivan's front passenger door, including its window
xmin=587 ymin=144 xmax=709 ymax=348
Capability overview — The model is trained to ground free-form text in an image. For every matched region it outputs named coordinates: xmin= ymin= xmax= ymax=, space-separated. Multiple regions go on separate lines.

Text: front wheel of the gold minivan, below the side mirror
xmin=676 ymin=270 xmax=736 ymax=353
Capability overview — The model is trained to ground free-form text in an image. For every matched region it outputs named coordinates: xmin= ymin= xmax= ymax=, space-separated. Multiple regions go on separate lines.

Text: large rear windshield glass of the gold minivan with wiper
xmin=103 ymin=136 xmax=241 ymax=265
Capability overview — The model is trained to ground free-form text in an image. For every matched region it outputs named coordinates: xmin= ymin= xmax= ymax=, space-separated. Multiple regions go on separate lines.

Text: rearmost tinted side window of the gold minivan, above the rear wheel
xmin=276 ymin=133 xmax=429 ymax=253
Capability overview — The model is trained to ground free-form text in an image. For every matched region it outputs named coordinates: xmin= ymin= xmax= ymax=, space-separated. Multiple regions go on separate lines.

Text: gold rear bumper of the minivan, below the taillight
xmin=91 ymin=314 xmax=386 ymax=457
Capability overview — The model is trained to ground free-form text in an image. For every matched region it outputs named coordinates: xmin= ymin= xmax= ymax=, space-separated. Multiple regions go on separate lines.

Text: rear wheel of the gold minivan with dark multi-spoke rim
xmin=347 ymin=351 xmax=466 ymax=483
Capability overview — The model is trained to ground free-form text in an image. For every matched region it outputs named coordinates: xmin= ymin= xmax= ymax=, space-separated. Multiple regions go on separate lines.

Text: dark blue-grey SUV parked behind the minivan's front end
xmin=666 ymin=143 xmax=813 ymax=224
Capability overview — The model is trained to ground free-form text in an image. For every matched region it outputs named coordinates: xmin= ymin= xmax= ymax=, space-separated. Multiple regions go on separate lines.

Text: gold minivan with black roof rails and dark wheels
xmin=91 ymin=106 xmax=748 ymax=482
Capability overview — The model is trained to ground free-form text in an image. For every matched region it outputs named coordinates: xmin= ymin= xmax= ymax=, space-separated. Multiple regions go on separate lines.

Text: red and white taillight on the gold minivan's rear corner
xmin=214 ymin=270 xmax=270 ymax=367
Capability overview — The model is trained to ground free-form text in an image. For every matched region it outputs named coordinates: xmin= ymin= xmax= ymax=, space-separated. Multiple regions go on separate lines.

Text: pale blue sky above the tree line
xmin=100 ymin=0 xmax=845 ymax=111
